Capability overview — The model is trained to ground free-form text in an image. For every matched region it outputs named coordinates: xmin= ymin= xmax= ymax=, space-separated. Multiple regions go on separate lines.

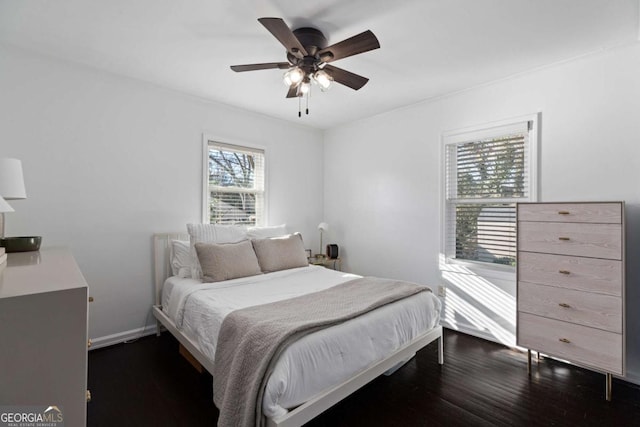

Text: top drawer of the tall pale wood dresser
xmin=518 ymin=203 xmax=622 ymax=224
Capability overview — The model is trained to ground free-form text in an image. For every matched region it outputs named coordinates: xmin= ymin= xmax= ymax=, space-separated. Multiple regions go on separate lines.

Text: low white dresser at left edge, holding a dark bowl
xmin=0 ymin=248 xmax=88 ymax=426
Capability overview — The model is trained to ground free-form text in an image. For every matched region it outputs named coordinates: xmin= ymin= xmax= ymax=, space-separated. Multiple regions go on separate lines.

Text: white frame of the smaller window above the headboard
xmin=201 ymin=133 xmax=269 ymax=226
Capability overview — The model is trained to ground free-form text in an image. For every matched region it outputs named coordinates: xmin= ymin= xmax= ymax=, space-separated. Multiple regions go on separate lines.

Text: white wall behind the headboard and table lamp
xmin=0 ymin=46 xmax=323 ymax=339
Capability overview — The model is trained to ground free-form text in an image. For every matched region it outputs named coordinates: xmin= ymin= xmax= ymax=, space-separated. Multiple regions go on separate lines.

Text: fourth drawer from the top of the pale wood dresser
xmin=518 ymin=282 xmax=622 ymax=333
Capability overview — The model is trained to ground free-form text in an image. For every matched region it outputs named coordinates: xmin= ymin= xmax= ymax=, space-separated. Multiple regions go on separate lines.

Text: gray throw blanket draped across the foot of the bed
xmin=213 ymin=277 xmax=429 ymax=427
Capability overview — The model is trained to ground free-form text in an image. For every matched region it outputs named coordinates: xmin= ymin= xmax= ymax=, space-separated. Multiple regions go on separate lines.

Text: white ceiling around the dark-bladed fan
xmin=0 ymin=0 xmax=640 ymax=129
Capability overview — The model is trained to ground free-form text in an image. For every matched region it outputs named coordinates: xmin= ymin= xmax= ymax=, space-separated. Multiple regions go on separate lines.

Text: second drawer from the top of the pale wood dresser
xmin=518 ymin=222 xmax=622 ymax=260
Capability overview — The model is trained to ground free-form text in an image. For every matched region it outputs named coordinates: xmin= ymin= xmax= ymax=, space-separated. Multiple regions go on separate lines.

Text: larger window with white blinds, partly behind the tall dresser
xmin=443 ymin=115 xmax=537 ymax=266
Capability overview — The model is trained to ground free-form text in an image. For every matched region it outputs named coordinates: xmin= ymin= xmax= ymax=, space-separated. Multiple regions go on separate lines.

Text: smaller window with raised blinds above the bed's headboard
xmin=204 ymin=141 xmax=265 ymax=225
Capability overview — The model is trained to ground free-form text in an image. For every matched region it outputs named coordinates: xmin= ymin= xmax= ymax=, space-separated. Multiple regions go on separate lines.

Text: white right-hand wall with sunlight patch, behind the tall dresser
xmin=324 ymin=44 xmax=640 ymax=382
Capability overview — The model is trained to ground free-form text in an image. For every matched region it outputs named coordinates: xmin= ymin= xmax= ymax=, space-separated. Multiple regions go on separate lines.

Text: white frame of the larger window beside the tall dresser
xmin=440 ymin=113 xmax=540 ymax=276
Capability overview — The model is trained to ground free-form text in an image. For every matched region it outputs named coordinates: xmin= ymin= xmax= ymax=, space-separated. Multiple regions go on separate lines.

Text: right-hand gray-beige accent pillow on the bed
xmin=252 ymin=233 xmax=309 ymax=273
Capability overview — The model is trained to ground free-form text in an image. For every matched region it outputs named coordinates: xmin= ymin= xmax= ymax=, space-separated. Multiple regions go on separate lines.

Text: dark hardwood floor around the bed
xmin=88 ymin=330 xmax=640 ymax=427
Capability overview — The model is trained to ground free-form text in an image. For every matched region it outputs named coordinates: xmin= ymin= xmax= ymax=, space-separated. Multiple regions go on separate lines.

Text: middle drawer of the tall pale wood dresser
xmin=518 ymin=252 xmax=622 ymax=296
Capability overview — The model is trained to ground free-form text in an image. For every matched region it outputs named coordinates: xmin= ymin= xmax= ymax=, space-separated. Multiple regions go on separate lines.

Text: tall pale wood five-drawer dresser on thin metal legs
xmin=517 ymin=202 xmax=625 ymax=400
